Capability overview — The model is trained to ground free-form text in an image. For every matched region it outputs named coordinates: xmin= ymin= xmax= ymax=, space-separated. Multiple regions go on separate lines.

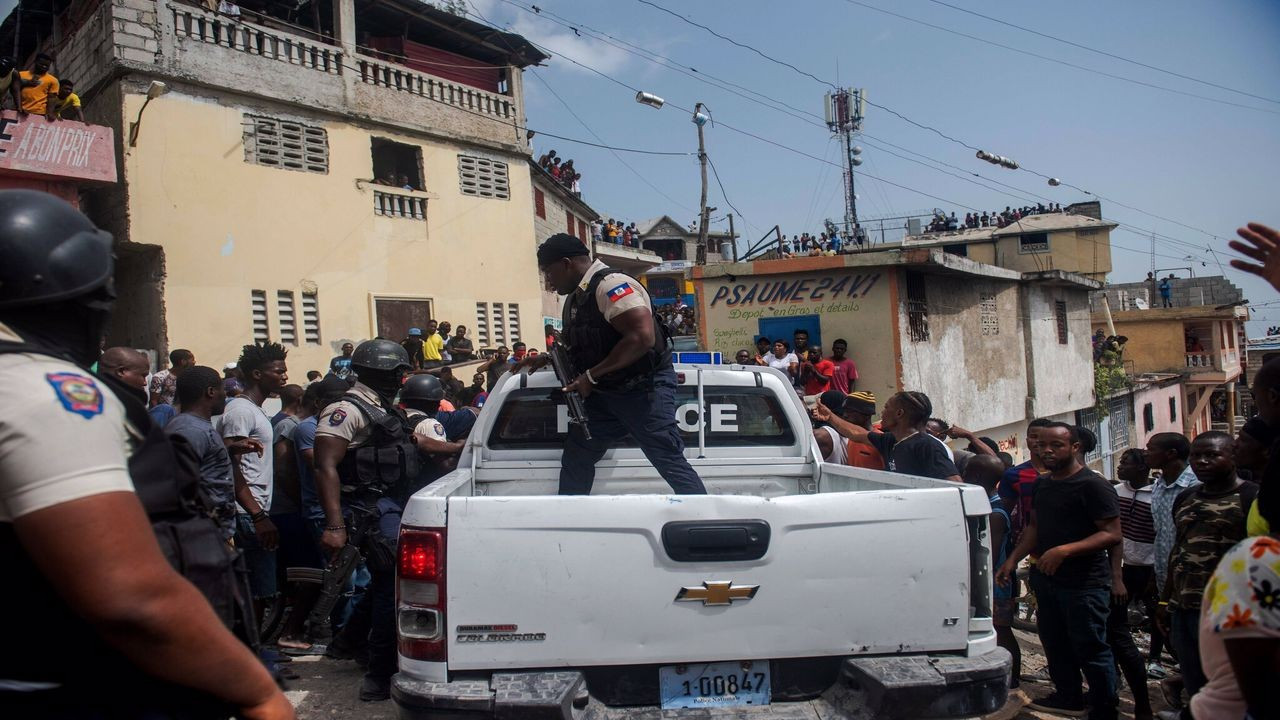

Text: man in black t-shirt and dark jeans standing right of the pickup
xmin=996 ymin=423 xmax=1121 ymax=720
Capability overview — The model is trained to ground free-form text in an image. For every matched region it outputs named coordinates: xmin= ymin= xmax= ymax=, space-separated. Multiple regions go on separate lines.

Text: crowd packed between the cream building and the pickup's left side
xmin=120 ymin=313 xmax=557 ymax=700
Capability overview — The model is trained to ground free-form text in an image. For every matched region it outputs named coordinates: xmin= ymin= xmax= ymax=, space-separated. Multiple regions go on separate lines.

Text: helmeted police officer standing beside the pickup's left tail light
xmin=314 ymin=338 xmax=421 ymax=701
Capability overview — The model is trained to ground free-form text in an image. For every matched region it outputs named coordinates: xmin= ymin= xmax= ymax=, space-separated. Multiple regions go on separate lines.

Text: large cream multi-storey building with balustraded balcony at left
xmin=10 ymin=0 xmax=545 ymax=375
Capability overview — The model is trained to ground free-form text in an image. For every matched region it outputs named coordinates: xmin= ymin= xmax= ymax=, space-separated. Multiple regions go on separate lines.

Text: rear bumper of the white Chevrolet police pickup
xmin=392 ymin=648 xmax=1011 ymax=720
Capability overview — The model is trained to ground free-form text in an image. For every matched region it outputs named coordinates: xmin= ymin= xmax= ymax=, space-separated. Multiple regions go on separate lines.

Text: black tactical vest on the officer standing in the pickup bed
xmin=562 ymin=268 xmax=671 ymax=391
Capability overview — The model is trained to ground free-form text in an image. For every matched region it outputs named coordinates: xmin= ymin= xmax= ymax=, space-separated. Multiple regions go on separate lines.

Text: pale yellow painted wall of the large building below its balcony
xmin=124 ymin=91 xmax=541 ymax=368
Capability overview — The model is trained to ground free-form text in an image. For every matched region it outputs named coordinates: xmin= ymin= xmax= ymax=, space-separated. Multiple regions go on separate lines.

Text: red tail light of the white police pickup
xmin=396 ymin=528 xmax=448 ymax=662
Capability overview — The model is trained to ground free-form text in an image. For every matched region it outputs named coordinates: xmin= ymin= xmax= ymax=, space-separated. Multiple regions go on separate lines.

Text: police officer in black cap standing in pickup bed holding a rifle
xmin=521 ymin=233 xmax=707 ymax=495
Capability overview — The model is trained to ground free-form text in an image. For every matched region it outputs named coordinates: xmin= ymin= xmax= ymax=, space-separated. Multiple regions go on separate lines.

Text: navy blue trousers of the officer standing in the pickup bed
xmin=559 ymin=368 xmax=707 ymax=495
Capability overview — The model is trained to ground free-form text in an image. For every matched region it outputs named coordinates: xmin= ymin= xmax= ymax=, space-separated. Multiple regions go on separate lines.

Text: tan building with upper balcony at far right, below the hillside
xmin=1093 ymin=305 xmax=1248 ymax=437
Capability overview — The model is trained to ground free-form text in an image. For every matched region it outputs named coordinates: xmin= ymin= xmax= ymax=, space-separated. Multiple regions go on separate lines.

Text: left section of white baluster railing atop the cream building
xmin=170 ymin=5 xmax=342 ymax=76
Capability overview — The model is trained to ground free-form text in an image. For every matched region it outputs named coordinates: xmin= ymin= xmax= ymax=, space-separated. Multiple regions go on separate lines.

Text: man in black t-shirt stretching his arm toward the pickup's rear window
xmin=814 ymin=391 xmax=963 ymax=483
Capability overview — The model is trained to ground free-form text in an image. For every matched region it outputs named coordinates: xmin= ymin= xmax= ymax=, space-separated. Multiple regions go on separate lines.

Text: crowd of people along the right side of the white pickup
xmin=788 ymin=353 xmax=1280 ymax=720
